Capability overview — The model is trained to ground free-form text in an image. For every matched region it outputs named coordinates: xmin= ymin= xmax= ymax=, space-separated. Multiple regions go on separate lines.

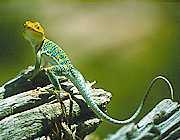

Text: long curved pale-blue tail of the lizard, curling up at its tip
xmin=67 ymin=68 xmax=173 ymax=125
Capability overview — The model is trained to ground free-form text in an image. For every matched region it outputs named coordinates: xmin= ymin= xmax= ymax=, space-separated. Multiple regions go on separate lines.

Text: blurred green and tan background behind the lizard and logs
xmin=0 ymin=2 xmax=180 ymax=139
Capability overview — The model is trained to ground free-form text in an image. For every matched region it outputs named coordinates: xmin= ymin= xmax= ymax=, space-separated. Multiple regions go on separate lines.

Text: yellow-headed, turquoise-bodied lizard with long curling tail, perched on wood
xmin=23 ymin=21 xmax=173 ymax=125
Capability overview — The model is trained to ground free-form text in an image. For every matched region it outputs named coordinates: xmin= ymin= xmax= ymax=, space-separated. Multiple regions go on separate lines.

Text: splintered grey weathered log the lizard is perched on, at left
xmin=0 ymin=69 xmax=111 ymax=140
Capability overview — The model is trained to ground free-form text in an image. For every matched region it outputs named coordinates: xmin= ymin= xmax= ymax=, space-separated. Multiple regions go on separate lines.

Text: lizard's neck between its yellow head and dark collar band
xmin=30 ymin=37 xmax=45 ymax=54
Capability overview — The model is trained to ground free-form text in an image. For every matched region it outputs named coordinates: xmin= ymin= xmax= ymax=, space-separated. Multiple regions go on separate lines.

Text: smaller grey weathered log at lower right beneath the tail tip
xmin=106 ymin=99 xmax=180 ymax=140
